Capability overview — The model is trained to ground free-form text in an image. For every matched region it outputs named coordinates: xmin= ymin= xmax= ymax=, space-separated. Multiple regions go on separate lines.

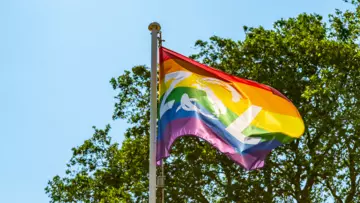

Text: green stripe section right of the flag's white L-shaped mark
xmin=242 ymin=125 xmax=295 ymax=144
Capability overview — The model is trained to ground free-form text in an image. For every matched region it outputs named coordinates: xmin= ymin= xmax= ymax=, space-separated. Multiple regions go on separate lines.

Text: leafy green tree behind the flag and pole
xmin=45 ymin=1 xmax=360 ymax=202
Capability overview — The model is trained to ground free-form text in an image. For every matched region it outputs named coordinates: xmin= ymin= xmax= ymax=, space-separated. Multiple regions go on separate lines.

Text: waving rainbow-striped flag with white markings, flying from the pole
xmin=157 ymin=47 xmax=304 ymax=170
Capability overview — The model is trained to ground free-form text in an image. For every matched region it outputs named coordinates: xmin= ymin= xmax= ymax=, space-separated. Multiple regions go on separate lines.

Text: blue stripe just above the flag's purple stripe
xmin=158 ymin=102 xmax=282 ymax=154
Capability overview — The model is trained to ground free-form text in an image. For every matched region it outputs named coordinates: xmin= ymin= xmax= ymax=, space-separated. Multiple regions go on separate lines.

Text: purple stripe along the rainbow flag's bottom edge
xmin=156 ymin=118 xmax=270 ymax=170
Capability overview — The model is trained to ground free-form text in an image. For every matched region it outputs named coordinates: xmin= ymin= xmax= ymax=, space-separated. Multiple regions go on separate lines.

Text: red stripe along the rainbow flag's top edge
xmin=160 ymin=47 xmax=291 ymax=102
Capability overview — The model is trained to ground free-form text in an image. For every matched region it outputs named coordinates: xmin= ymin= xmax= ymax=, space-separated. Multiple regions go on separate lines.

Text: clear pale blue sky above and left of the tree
xmin=0 ymin=0 xmax=348 ymax=203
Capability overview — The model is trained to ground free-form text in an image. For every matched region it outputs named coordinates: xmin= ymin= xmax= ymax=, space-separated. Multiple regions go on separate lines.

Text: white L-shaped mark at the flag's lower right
xmin=226 ymin=105 xmax=261 ymax=144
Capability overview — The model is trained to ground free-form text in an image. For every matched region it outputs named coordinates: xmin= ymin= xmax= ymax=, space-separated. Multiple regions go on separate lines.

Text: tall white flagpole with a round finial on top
xmin=149 ymin=22 xmax=160 ymax=203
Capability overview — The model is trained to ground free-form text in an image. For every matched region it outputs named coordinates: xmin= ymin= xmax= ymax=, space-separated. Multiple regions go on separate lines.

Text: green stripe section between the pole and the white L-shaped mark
xmin=160 ymin=87 xmax=238 ymax=126
